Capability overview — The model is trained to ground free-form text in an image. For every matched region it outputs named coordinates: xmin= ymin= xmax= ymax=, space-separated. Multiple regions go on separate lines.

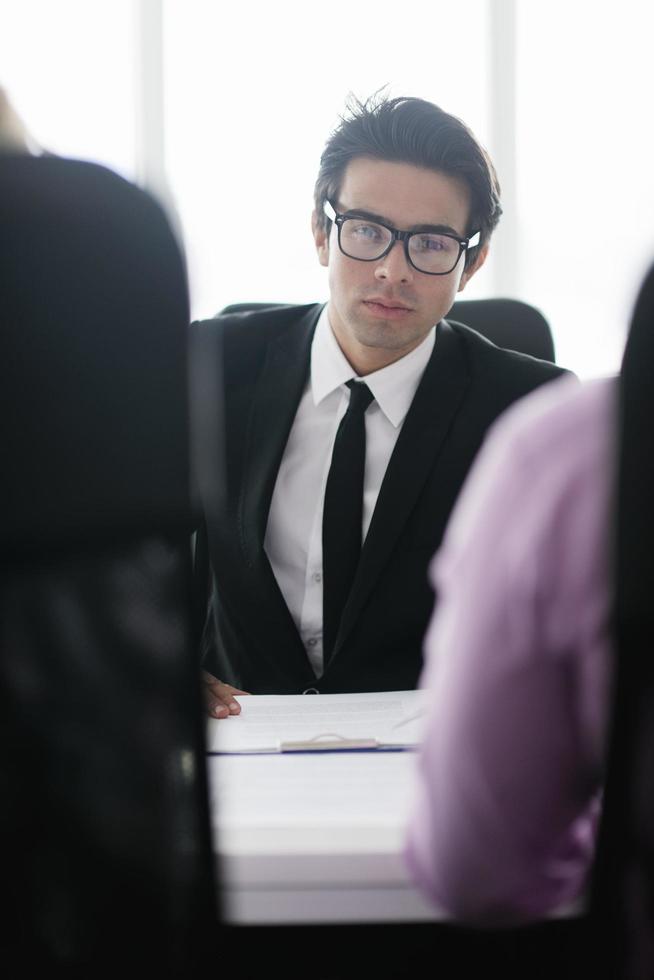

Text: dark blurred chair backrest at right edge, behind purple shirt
xmin=589 ymin=266 xmax=654 ymax=980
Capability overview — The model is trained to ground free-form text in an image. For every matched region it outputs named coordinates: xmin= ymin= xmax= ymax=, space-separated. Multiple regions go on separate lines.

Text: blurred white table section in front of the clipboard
xmin=208 ymin=751 xmax=443 ymax=925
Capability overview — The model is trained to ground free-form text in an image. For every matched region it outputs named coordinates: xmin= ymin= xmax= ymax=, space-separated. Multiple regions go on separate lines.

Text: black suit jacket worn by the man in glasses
xmin=192 ymin=304 xmax=564 ymax=694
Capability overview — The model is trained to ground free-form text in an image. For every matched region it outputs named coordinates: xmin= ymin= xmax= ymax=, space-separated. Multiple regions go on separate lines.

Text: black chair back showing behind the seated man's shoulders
xmin=220 ymin=299 xmax=555 ymax=363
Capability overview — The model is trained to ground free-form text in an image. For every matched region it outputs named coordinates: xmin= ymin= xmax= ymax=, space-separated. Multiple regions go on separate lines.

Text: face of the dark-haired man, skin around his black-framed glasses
xmin=314 ymin=157 xmax=487 ymax=374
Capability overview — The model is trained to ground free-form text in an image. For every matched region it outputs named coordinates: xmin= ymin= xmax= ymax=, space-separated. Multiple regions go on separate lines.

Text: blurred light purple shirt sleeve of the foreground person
xmin=406 ymin=380 xmax=614 ymax=925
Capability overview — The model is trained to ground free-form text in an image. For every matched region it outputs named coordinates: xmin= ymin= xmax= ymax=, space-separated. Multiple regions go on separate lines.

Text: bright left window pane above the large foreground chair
xmin=0 ymin=0 xmax=136 ymax=179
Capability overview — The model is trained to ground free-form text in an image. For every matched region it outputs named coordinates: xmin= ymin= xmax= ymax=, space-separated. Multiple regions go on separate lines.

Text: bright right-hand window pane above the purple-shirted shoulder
xmin=516 ymin=0 xmax=654 ymax=377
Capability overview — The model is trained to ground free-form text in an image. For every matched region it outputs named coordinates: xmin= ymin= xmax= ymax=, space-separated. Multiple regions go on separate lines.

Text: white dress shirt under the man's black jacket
xmin=264 ymin=307 xmax=435 ymax=677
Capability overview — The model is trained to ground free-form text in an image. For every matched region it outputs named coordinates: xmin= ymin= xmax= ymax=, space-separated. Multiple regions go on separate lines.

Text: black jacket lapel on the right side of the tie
xmin=334 ymin=321 xmax=470 ymax=654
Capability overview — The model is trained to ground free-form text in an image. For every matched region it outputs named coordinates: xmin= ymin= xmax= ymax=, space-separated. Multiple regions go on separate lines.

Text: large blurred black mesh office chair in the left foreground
xmin=0 ymin=156 xmax=217 ymax=980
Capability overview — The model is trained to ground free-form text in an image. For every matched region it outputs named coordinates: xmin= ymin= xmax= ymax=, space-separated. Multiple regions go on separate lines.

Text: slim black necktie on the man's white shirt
xmin=322 ymin=381 xmax=373 ymax=662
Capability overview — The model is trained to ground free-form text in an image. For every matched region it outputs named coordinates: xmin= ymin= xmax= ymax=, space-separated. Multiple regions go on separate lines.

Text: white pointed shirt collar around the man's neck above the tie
xmin=311 ymin=306 xmax=436 ymax=428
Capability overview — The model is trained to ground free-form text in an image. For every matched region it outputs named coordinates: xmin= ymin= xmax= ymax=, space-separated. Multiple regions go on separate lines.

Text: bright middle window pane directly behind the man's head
xmin=164 ymin=0 xmax=488 ymax=316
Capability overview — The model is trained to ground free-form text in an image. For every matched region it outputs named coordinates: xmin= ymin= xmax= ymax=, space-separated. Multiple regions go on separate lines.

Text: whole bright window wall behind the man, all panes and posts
xmin=0 ymin=0 xmax=654 ymax=377
